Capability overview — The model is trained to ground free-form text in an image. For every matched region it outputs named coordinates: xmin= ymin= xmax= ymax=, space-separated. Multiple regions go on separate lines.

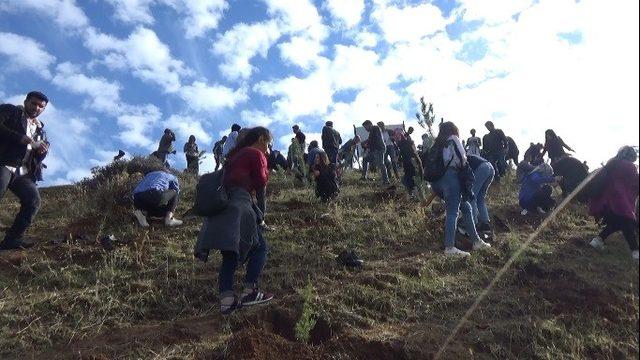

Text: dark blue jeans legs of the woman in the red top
xmin=218 ymin=230 xmax=268 ymax=298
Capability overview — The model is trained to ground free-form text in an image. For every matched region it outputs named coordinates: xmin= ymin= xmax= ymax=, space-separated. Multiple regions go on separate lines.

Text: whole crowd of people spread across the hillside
xmin=0 ymin=92 xmax=638 ymax=314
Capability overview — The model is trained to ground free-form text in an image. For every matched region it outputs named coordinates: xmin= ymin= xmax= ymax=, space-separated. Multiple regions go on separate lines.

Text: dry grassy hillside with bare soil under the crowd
xmin=0 ymin=164 xmax=639 ymax=359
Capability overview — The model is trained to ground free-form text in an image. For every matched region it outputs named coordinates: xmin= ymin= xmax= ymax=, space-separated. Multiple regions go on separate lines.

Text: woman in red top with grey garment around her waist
xmin=194 ymin=127 xmax=273 ymax=314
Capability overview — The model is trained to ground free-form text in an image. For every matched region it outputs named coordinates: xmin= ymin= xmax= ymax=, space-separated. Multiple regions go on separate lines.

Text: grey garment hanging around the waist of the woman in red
xmin=194 ymin=188 xmax=262 ymax=262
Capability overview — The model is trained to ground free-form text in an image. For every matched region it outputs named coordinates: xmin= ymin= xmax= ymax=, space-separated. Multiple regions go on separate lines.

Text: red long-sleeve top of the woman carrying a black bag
xmin=224 ymin=146 xmax=269 ymax=193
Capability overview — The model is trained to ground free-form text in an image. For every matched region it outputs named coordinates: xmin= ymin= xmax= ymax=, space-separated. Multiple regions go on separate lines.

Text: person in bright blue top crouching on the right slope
xmin=520 ymin=163 xmax=562 ymax=215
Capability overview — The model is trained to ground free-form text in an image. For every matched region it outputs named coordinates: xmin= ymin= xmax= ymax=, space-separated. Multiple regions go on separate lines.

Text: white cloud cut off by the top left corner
xmin=0 ymin=0 xmax=89 ymax=30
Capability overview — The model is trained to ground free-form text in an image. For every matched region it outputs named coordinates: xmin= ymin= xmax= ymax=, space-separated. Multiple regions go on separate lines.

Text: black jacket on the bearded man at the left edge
xmin=0 ymin=104 xmax=49 ymax=181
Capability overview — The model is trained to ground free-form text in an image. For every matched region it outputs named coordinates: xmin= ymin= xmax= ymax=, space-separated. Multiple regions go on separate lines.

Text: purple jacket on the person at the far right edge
xmin=589 ymin=160 xmax=639 ymax=220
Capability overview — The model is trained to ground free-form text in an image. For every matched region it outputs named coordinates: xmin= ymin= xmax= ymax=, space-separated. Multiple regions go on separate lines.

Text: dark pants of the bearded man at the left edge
xmin=0 ymin=165 xmax=40 ymax=241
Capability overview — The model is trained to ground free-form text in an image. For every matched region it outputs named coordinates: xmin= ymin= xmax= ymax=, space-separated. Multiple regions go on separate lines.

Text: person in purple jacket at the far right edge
xmin=589 ymin=146 xmax=640 ymax=262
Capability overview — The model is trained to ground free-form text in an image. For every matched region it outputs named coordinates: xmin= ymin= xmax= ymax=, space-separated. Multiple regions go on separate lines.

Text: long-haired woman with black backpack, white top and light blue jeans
xmin=432 ymin=122 xmax=491 ymax=256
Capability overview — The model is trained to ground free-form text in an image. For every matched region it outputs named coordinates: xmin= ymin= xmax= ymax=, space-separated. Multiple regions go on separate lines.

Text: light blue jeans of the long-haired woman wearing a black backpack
xmin=433 ymin=168 xmax=480 ymax=249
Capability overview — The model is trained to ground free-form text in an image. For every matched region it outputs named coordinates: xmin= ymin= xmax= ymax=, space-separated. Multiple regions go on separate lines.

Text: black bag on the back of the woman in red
xmin=193 ymin=169 xmax=229 ymax=217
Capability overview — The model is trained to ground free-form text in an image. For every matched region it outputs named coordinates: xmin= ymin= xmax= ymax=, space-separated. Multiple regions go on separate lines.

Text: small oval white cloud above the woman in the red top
xmin=180 ymin=81 xmax=248 ymax=111
